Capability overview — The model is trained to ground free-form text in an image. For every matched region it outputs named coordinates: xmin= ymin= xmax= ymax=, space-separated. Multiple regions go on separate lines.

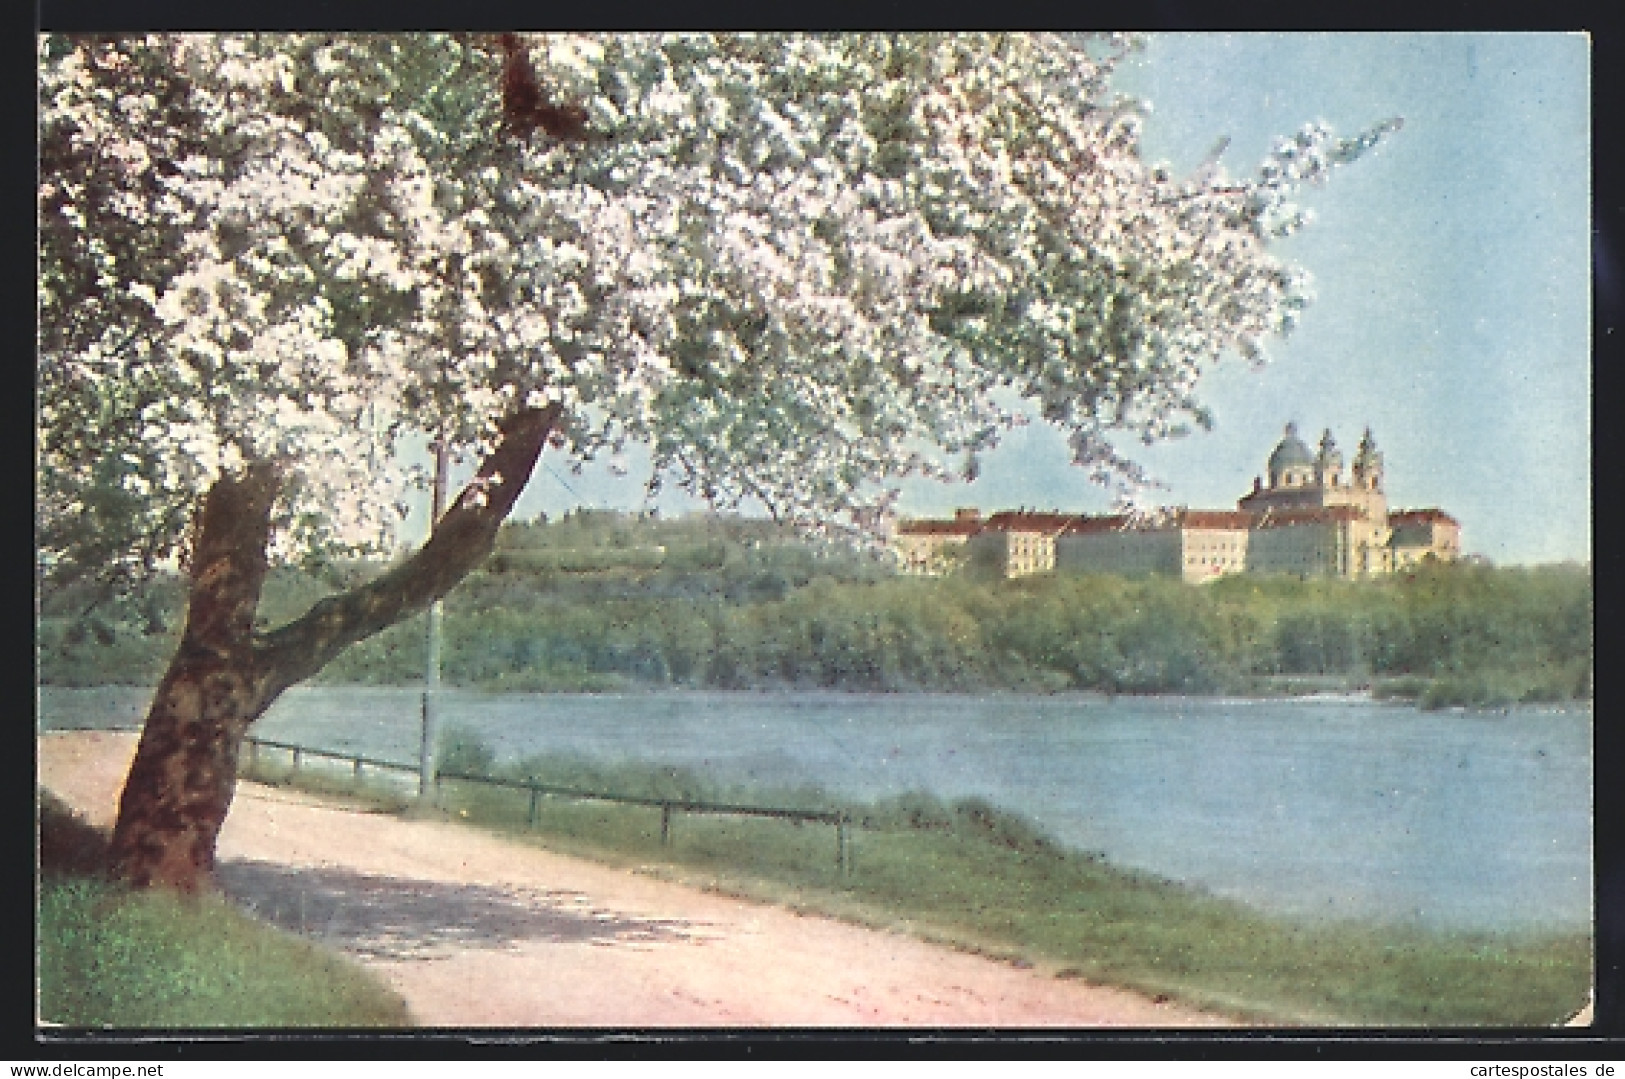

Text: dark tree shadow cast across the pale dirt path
xmin=216 ymin=860 xmax=694 ymax=959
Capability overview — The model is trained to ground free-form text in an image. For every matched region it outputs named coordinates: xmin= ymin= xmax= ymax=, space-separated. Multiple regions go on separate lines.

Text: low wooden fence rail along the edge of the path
xmin=245 ymin=735 xmax=852 ymax=876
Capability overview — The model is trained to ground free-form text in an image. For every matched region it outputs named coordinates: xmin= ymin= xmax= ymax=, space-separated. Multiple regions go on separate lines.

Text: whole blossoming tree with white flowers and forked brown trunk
xmin=37 ymin=34 xmax=1391 ymax=889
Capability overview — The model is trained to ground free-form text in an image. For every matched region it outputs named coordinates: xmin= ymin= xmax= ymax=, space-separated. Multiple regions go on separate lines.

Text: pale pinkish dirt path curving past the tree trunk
xmin=39 ymin=733 xmax=1224 ymax=1027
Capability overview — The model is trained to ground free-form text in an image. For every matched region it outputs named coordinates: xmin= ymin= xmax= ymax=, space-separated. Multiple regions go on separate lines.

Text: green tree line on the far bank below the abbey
xmin=41 ymin=512 xmax=1593 ymax=707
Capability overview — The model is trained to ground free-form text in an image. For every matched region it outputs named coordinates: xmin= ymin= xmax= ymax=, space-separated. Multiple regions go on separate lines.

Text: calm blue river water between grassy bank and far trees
xmin=39 ymin=687 xmax=1593 ymax=931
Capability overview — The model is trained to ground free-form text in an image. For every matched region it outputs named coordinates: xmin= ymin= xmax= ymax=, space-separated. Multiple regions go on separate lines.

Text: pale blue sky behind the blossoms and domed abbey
xmin=490 ymin=33 xmax=1591 ymax=564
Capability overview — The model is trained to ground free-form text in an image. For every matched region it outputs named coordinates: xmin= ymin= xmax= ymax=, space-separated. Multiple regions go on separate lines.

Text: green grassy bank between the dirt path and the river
xmin=247 ymin=736 xmax=1591 ymax=1027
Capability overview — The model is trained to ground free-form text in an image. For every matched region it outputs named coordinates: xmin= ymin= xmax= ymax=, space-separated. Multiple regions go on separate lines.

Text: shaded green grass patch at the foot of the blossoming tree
xmin=37 ymin=793 xmax=411 ymax=1029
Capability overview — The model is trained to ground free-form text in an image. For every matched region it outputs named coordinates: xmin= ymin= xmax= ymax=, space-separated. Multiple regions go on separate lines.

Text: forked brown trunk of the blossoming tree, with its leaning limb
xmin=109 ymin=405 xmax=559 ymax=892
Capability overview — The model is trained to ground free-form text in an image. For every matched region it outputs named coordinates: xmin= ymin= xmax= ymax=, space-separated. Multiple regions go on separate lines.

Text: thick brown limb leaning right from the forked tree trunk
xmin=255 ymin=405 xmax=562 ymax=712
